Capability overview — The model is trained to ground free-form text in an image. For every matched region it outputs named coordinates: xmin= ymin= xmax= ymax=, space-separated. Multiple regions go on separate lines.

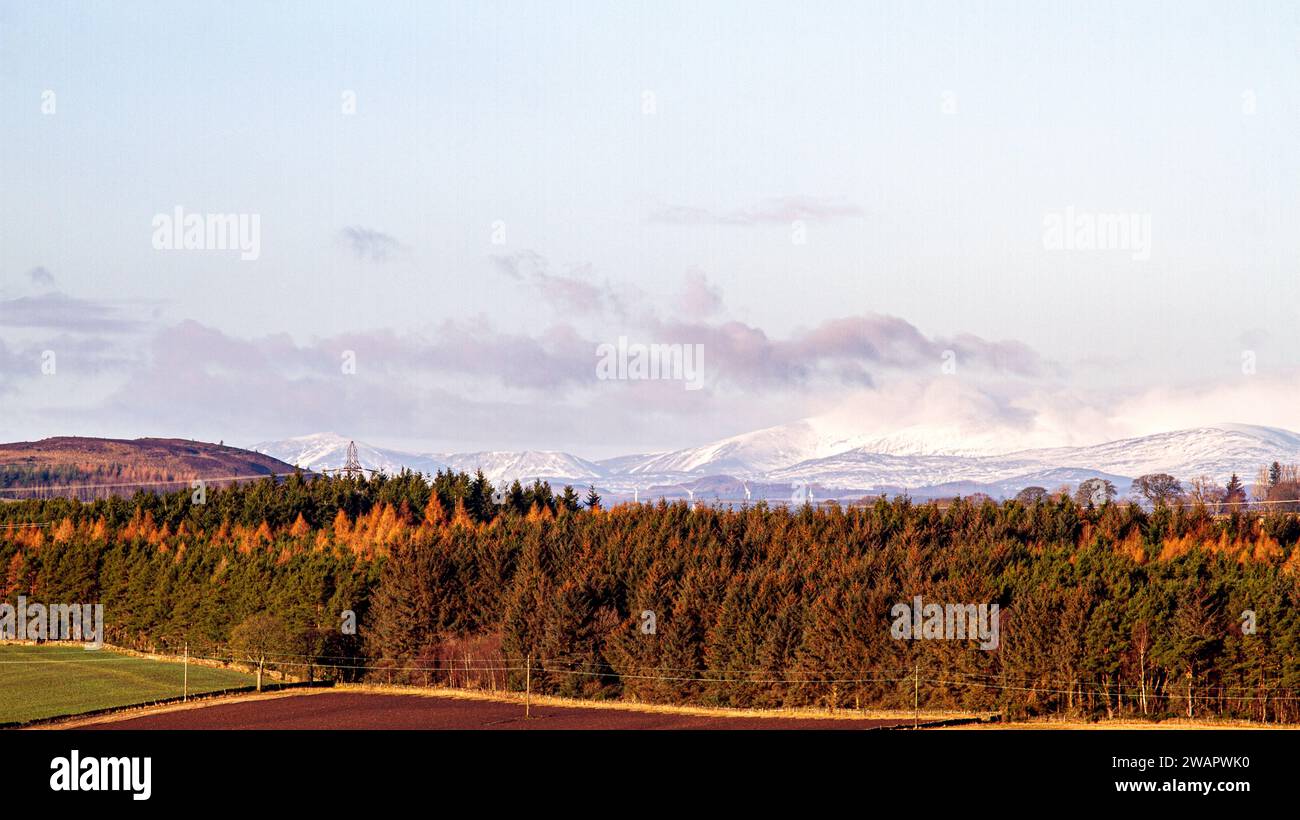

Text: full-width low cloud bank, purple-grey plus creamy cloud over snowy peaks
xmin=15 ymin=265 xmax=1274 ymax=455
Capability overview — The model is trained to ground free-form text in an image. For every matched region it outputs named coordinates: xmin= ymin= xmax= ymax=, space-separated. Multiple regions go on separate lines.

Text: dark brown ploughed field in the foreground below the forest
xmin=79 ymin=693 xmax=910 ymax=730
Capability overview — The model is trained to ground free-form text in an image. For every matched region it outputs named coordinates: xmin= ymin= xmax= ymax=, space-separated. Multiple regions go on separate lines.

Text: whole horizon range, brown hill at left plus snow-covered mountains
xmin=0 ymin=418 xmax=1300 ymax=500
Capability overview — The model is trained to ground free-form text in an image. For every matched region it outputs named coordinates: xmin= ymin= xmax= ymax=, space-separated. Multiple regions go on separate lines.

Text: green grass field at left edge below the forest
xmin=0 ymin=645 xmax=255 ymax=724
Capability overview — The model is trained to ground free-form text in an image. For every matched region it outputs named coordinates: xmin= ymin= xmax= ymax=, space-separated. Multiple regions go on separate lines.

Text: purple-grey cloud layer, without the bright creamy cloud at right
xmin=0 ymin=267 xmax=1054 ymax=450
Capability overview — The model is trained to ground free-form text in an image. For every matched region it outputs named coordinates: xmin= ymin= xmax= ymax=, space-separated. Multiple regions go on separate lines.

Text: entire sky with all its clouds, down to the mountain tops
xmin=0 ymin=1 xmax=1300 ymax=457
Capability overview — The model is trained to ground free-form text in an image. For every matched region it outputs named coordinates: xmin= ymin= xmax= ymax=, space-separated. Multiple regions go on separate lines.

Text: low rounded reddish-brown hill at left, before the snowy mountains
xmin=0 ymin=435 xmax=294 ymax=500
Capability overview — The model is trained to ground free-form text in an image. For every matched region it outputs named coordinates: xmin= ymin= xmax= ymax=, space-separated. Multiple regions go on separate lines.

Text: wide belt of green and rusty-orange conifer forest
xmin=0 ymin=473 xmax=1300 ymax=723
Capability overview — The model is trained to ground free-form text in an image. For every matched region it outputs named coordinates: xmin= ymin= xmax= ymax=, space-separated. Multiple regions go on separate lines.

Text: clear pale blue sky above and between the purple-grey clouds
xmin=0 ymin=1 xmax=1300 ymax=448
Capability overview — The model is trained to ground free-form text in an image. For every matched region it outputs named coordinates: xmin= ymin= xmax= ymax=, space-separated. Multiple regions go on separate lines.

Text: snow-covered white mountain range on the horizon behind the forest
xmin=255 ymin=418 xmax=1300 ymax=500
